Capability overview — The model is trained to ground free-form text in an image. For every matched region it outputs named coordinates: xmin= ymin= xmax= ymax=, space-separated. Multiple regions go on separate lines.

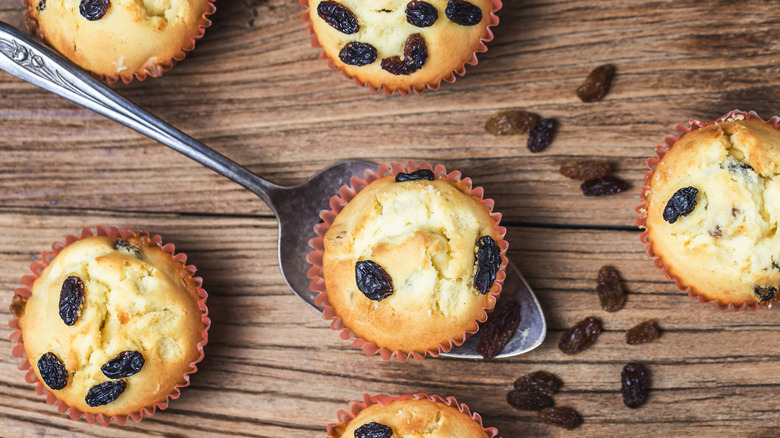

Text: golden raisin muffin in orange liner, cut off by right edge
xmin=640 ymin=112 xmax=780 ymax=309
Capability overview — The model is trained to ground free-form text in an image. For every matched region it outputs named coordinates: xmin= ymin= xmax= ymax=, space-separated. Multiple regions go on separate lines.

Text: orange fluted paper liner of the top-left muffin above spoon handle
xmin=22 ymin=0 xmax=217 ymax=84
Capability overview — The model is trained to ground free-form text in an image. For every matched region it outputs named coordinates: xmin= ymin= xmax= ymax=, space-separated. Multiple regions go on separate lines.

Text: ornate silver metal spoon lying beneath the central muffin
xmin=0 ymin=22 xmax=547 ymax=359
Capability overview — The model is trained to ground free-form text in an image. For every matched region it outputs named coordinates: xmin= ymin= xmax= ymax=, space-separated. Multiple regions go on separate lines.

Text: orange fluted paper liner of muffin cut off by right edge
xmin=636 ymin=110 xmax=780 ymax=312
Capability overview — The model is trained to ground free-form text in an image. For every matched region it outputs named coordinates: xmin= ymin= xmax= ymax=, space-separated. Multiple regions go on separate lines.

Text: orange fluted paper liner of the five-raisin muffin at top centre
xmin=298 ymin=0 xmax=503 ymax=97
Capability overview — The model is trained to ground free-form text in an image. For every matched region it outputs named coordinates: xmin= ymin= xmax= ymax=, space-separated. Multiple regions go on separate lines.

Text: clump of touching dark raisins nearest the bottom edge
xmin=506 ymin=371 xmax=582 ymax=429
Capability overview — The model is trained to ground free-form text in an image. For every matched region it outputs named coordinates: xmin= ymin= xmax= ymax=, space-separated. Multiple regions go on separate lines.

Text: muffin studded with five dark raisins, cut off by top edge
xmin=301 ymin=0 xmax=501 ymax=95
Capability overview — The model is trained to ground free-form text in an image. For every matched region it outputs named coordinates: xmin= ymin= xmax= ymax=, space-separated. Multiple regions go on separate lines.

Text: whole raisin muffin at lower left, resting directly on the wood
xmin=12 ymin=229 xmax=209 ymax=422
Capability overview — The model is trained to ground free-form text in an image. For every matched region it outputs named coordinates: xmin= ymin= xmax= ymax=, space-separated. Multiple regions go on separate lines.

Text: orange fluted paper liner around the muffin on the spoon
xmin=306 ymin=160 xmax=509 ymax=362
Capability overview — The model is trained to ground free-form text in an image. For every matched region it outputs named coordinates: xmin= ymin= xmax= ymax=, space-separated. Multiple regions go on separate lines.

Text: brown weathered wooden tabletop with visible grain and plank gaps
xmin=0 ymin=0 xmax=780 ymax=438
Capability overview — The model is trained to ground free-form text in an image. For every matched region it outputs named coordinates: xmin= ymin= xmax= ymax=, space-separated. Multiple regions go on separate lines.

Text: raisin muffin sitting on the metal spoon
xmin=308 ymin=164 xmax=507 ymax=359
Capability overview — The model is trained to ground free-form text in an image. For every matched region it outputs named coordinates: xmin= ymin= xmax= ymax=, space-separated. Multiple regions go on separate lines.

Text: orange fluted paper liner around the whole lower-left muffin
xmin=8 ymin=226 xmax=211 ymax=426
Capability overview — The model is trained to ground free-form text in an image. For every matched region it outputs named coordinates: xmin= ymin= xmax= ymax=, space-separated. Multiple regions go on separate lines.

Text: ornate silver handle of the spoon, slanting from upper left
xmin=0 ymin=21 xmax=278 ymax=208
